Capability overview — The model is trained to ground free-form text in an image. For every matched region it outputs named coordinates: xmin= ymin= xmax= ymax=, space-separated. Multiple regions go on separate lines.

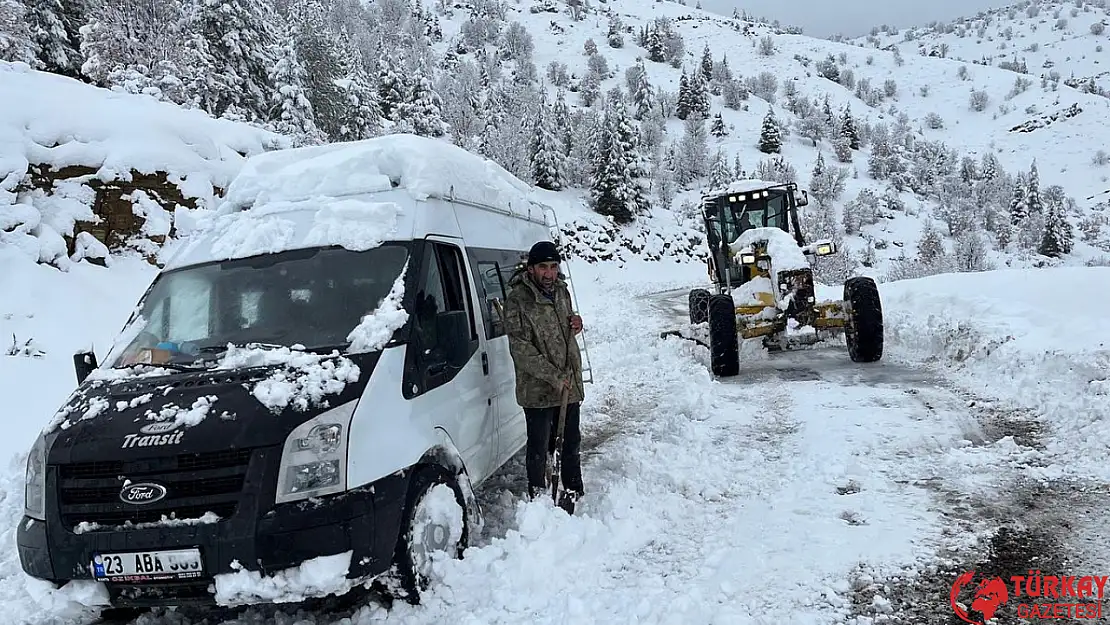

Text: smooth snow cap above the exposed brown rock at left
xmin=0 ymin=61 xmax=281 ymax=204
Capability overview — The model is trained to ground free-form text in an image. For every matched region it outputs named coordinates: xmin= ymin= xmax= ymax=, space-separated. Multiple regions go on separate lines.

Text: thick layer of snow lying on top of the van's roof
xmin=220 ymin=134 xmax=533 ymax=212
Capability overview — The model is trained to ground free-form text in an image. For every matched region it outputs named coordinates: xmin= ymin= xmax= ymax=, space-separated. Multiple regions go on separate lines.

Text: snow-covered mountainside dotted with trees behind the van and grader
xmin=6 ymin=0 xmax=1110 ymax=283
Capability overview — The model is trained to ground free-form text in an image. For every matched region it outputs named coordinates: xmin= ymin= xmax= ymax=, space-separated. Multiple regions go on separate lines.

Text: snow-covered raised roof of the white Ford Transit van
xmin=165 ymin=134 xmax=549 ymax=270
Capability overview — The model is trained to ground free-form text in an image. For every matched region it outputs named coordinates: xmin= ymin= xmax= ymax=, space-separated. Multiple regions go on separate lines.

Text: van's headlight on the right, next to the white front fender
xmin=275 ymin=400 xmax=359 ymax=504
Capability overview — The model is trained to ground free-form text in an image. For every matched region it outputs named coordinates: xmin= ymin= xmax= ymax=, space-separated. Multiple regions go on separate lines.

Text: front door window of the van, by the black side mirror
xmin=405 ymin=241 xmax=478 ymax=396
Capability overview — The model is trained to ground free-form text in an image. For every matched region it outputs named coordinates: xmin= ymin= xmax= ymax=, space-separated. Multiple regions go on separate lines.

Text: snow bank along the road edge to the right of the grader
xmin=880 ymin=268 xmax=1110 ymax=480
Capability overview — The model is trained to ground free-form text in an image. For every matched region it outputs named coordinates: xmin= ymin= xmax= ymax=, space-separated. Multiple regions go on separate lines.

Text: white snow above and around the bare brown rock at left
xmin=0 ymin=61 xmax=290 ymax=262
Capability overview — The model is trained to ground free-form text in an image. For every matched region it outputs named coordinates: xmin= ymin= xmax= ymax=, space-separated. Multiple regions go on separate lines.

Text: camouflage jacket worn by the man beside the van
xmin=504 ymin=271 xmax=585 ymax=409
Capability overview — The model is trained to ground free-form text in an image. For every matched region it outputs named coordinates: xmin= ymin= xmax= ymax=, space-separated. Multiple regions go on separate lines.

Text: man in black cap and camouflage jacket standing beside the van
xmin=504 ymin=241 xmax=585 ymax=514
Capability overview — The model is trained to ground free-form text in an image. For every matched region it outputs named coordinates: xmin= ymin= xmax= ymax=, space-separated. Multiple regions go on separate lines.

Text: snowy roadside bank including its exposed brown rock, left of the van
xmin=0 ymin=61 xmax=290 ymax=270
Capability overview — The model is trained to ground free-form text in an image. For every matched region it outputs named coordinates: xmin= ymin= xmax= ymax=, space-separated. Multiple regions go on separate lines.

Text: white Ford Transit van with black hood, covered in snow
xmin=18 ymin=135 xmax=572 ymax=607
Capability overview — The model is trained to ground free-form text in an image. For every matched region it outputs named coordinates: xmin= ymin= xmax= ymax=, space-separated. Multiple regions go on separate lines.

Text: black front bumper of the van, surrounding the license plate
xmin=17 ymin=463 xmax=408 ymax=607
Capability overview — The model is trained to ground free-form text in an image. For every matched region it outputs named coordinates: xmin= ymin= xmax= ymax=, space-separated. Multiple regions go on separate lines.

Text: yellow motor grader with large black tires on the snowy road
xmin=663 ymin=180 xmax=882 ymax=377
